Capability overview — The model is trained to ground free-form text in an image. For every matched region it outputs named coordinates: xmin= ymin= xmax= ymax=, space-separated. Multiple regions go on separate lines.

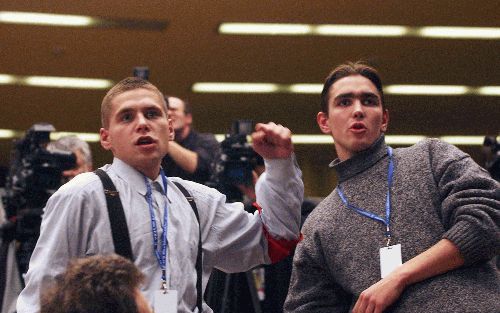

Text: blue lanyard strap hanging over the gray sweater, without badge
xmin=337 ymin=147 xmax=394 ymax=246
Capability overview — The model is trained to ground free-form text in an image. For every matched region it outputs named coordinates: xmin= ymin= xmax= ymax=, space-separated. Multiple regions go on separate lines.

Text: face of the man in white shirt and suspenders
xmin=100 ymin=89 xmax=173 ymax=179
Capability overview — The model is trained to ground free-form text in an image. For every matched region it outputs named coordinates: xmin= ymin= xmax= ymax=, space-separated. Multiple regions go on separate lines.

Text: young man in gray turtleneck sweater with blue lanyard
xmin=285 ymin=63 xmax=500 ymax=313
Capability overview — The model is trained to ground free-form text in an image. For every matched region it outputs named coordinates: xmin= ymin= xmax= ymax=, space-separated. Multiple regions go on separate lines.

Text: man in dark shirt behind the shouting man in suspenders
xmin=162 ymin=96 xmax=220 ymax=184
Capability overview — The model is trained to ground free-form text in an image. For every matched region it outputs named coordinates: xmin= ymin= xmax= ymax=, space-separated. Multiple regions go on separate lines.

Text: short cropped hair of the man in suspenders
xmin=101 ymin=77 xmax=167 ymax=129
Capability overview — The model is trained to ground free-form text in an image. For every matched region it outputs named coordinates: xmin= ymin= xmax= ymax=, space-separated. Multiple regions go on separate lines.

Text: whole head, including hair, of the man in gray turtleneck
xmin=316 ymin=62 xmax=389 ymax=161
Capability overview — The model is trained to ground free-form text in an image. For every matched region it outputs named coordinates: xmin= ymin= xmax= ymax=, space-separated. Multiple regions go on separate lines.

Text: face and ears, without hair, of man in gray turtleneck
xmin=317 ymin=75 xmax=389 ymax=161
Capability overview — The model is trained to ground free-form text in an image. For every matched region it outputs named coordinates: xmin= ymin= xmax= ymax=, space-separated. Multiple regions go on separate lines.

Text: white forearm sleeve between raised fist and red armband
xmin=255 ymin=154 xmax=304 ymax=240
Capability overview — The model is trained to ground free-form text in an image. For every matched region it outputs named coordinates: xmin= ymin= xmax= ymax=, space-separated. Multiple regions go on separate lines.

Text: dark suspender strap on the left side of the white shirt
xmin=94 ymin=169 xmax=134 ymax=261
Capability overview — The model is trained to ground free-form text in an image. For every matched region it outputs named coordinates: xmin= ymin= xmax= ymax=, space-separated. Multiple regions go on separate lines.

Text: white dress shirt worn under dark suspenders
xmin=17 ymin=156 xmax=304 ymax=313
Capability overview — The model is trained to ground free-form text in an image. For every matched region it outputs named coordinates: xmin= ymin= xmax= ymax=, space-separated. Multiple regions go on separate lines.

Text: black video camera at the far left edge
xmin=0 ymin=123 xmax=76 ymax=273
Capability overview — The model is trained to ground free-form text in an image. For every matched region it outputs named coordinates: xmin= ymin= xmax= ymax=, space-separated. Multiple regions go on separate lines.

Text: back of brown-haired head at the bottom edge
xmin=40 ymin=255 xmax=152 ymax=313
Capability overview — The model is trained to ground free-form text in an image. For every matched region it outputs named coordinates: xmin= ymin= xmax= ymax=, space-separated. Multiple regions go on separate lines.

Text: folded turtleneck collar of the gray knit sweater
xmin=329 ymin=134 xmax=387 ymax=182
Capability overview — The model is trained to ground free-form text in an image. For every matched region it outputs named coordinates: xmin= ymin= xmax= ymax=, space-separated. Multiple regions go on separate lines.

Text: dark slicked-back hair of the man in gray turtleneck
xmin=321 ymin=61 xmax=385 ymax=113
